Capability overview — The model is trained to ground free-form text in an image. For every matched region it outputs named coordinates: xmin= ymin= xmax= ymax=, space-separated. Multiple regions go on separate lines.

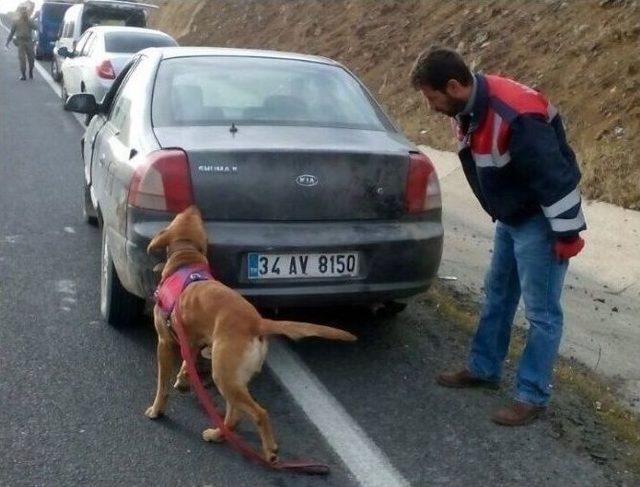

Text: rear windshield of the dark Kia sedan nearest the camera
xmin=152 ymin=56 xmax=392 ymax=130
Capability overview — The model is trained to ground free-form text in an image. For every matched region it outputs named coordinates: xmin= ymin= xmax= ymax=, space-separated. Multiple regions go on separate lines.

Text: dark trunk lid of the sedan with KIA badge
xmin=155 ymin=126 xmax=410 ymax=221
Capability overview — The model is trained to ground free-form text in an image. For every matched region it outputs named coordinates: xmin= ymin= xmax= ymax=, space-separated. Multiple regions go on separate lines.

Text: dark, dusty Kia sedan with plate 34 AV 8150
xmin=67 ymin=48 xmax=443 ymax=324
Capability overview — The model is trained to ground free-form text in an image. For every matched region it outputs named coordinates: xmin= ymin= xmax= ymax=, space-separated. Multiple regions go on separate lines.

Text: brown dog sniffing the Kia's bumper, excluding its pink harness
xmin=145 ymin=206 xmax=356 ymax=461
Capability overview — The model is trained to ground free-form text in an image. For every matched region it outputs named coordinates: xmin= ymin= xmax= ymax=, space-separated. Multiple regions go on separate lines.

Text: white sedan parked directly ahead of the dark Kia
xmin=58 ymin=26 xmax=178 ymax=103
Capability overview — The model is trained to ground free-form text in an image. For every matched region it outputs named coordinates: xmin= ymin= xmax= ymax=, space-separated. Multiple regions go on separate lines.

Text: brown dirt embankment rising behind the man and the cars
xmin=152 ymin=0 xmax=640 ymax=209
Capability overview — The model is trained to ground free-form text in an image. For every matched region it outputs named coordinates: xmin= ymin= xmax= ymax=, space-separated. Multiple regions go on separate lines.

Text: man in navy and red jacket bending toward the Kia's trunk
xmin=411 ymin=49 xmax=586 ymax=426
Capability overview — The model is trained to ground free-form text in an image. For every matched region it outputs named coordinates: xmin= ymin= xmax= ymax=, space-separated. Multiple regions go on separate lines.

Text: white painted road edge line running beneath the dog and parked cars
xmin=2 ymin=17 xmax=411 ymax=487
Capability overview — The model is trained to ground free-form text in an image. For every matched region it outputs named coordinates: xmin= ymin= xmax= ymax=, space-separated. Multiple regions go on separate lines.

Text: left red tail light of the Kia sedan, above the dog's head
xmin=129 ymin=149 xmax=193 ymax=213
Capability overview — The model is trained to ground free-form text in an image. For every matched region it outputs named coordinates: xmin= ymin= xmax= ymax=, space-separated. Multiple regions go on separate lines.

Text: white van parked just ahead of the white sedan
xmin=51 ymin=0 xmax=158 ymax=81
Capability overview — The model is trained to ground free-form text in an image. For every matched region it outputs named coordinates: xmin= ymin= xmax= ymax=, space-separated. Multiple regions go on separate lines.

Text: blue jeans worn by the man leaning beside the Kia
xmin=467 ymin=214 xmax=568 ymax=406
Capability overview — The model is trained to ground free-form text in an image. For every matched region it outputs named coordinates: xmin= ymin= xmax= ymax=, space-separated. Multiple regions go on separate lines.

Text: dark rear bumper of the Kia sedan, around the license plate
xmin=123 ymin=215 xmax=443 ymax=306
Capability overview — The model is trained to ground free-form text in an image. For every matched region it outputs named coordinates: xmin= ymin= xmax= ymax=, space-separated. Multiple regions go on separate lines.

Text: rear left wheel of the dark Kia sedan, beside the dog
xmin=100 ymin=226 xmax=144 ymax=328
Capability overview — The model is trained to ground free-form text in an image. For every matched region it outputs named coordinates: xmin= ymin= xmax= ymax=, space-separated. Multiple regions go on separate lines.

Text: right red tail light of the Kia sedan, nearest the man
xmin=404 ymin=152 xmax=442 ymax=213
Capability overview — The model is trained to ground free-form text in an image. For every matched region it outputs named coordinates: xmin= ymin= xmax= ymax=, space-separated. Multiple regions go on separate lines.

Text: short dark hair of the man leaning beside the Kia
xmin=411 ymin=48 xmax=473 ymax=91
